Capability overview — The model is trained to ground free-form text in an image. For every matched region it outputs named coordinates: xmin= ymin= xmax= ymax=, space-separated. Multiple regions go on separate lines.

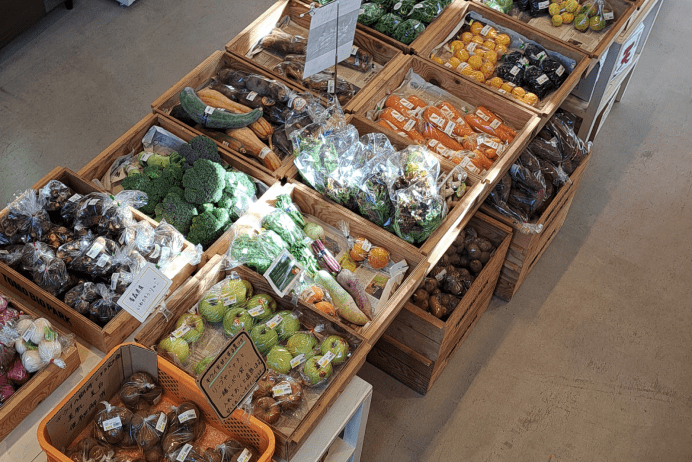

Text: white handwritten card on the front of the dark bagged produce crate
xmin=118 ymin=263 xmax=173 ymax=322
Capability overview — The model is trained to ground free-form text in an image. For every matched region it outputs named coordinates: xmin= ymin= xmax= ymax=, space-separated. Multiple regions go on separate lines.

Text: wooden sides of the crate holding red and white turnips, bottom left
xmin=0 ymin=291 xmax=81 ymax=441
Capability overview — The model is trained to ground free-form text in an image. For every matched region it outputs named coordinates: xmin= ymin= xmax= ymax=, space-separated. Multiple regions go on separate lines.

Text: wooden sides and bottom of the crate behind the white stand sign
xmin=226 ymin=0 xmax=401 ymax=112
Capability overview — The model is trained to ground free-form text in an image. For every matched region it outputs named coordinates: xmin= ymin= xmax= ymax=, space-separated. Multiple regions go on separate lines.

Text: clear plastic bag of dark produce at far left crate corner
xmin=3 ymin=189 xmax=51 ymax=243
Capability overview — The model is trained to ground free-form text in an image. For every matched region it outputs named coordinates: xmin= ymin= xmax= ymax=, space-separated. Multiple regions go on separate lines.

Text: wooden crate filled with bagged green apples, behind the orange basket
xmin=138 ymin=255 xmax=369 ymax=460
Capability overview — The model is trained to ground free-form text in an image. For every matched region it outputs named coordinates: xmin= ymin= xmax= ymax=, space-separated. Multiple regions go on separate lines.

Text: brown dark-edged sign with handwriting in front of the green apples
xmin=195 ymin=330 xmax=267 ymax=422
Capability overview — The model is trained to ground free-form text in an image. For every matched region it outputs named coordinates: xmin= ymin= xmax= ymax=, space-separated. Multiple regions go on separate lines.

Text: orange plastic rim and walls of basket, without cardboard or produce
xmin=37 ymin=343 xmax=276 ymax=462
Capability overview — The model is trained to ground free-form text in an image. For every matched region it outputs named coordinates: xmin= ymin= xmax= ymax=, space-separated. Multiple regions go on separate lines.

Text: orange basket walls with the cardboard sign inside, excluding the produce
xmin=37 ymin=343 xmax=275 ymax=462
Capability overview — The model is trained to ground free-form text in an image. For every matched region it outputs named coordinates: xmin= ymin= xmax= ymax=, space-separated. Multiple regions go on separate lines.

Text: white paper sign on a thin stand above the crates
xmin=303 ymin=0 xmax=360 ymax=79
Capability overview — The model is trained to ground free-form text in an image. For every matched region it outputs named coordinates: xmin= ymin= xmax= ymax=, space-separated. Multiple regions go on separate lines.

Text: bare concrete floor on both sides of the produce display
xmin=0 ymin=0 xmax=692 ymax=462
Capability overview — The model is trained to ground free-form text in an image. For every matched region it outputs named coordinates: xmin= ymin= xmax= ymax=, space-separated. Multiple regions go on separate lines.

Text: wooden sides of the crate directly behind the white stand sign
xmin=226 ymin=0 xmax=401 ymax=112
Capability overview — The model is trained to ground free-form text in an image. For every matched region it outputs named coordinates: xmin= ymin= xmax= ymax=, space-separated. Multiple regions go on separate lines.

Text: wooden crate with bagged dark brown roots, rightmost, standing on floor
xmin=481 ymin=111 xmax=591 ymax=301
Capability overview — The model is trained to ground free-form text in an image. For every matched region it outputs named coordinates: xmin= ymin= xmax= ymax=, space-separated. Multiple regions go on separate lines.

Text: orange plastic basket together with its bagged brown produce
xmin=38 ymin=343 xmax=275 ymax=462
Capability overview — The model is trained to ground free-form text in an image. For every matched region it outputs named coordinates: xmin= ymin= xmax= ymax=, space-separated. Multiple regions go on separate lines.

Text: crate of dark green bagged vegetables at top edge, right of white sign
xmin=358 ymin=0 xmax=463 ymax=54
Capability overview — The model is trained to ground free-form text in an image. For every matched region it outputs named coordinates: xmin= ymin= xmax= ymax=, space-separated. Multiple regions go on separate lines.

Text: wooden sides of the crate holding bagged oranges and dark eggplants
xmin=414 ymin=2 xmax=591 ymax=120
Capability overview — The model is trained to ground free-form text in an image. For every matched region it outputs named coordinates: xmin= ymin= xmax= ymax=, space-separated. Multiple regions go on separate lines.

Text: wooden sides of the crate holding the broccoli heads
xmin=79 ymin=113 xmax=278 ymax=265
